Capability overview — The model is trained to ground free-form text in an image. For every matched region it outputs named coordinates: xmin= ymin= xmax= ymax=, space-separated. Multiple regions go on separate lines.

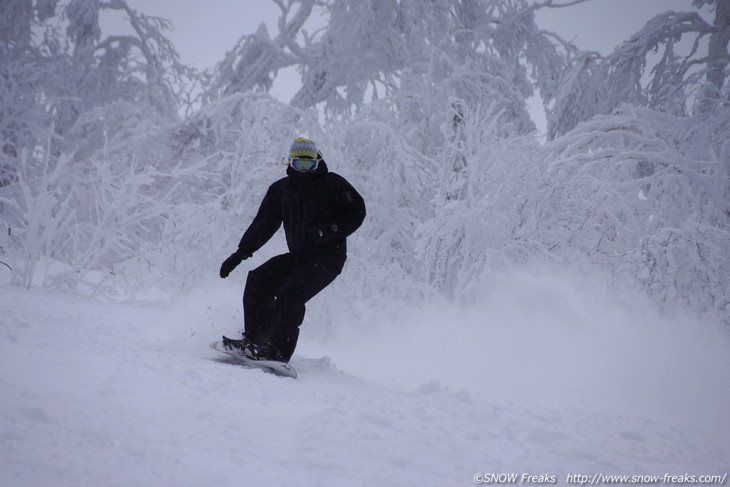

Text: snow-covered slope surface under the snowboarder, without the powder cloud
xmin=0 ymin=285 xmax=730 ymax=487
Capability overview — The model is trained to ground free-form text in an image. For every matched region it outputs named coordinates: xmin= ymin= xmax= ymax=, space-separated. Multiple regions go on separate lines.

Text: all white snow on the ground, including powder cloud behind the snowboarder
xmin=0 ymin=273 xmax=730 ymax=487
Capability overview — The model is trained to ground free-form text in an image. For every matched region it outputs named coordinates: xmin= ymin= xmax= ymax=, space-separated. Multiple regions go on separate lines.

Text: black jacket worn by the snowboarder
xmin=238 ymin=161 xmax=365 ymax=255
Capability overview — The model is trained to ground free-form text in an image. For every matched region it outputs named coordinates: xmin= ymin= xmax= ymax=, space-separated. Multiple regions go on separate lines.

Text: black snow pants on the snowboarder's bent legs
xmin=243 ymin=253 xmax=346 ymax=361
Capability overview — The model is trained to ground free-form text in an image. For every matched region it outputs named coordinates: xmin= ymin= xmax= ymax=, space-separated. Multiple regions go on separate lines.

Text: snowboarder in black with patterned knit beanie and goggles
xmin=220 ymin=137 xmax=365 ymax=362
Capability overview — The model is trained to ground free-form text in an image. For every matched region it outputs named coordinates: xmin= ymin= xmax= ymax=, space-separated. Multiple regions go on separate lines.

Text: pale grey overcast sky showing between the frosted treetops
xmin=103 ymin=0 xmax=695 ymax=131
